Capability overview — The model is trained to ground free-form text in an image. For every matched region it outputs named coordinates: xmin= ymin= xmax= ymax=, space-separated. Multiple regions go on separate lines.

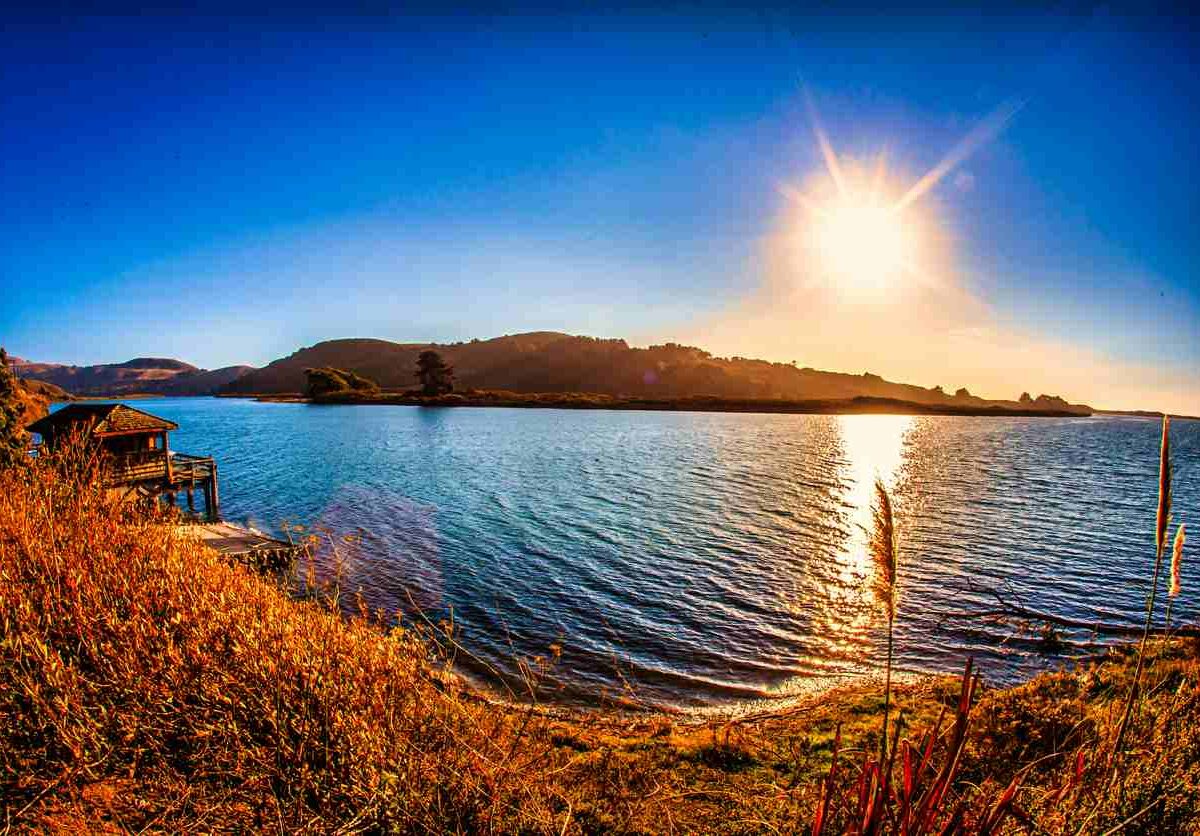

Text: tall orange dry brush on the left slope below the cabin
xmin=0 ymin=450 xmax=571 ymax=831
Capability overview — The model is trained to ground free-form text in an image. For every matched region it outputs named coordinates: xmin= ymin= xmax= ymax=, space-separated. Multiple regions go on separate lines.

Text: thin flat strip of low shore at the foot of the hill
xmin=225 ymin=392 xmax=1093 ymax=417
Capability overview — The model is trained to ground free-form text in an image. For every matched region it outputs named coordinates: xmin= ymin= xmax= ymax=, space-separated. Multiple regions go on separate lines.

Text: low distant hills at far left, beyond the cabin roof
xmin=13 ymin=357 xmax=252 ymax=396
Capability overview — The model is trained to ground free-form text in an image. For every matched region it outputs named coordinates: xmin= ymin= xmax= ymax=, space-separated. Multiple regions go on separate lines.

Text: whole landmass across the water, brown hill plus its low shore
xmin=226 ymin=331 xmax=1092 ymax=415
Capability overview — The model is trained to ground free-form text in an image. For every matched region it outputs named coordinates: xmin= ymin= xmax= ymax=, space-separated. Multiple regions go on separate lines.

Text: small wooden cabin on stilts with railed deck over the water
xmin=28 ymin=403 xmax=221 ymax=522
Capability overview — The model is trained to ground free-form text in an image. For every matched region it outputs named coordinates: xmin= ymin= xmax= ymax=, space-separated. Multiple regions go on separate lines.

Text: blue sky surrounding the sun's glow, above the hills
xmin=0 ymin=10 xmax=1200 ymax=413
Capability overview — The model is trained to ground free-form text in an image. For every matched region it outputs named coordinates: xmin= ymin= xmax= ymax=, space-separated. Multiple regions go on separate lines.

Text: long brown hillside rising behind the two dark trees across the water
xmin=224 ymin=331 xmax=1091 ymax=414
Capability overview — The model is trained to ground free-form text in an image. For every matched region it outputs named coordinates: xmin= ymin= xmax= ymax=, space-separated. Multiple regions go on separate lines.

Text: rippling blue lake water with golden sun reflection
xmin=68 ymin=398 xmax=1200 ymax=706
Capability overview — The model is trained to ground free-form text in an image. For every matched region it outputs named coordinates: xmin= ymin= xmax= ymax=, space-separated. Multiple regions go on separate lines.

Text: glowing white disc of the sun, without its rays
xmin=812 ymin=203 xmax=913 ymax=289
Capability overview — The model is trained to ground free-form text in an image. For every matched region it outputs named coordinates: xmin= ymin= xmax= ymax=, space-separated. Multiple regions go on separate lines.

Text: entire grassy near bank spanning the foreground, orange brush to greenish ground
xmin=0 ymin=441 xmax=1200 ymax=834
